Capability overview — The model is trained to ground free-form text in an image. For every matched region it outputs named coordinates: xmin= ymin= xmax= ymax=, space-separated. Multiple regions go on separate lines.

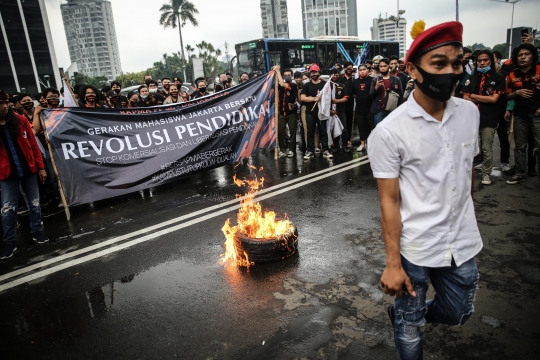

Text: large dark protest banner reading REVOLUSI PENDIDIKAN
xmin=43 ymin=71 xmax=277 ymax=206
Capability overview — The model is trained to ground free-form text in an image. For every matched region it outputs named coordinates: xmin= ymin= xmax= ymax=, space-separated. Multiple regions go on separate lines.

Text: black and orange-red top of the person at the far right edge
xmin=506 ymin=64 xmax=540 ymax=116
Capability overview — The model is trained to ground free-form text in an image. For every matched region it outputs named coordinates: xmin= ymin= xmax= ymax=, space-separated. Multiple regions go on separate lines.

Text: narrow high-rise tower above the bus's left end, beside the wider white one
xmin=261 ymin=0 xmax=289 ymax=39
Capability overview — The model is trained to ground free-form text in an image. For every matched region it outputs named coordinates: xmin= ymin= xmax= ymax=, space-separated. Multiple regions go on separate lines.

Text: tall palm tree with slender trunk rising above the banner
xmin=159 ymin=0 xmax=199 ymax=81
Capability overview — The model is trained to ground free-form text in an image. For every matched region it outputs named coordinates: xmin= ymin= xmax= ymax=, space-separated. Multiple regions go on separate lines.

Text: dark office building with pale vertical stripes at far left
xmin=0 ymin=0 xmax=61 ymax=95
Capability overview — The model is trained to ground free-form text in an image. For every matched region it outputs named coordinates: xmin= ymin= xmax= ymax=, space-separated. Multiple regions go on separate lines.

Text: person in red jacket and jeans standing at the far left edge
xmin=0 ymin=90 xmax=49 ymax=259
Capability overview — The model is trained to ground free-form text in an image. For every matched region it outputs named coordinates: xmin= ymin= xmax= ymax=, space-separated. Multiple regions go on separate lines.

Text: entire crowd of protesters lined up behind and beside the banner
xmin=0 ymin=31 xmax=540 ymax=258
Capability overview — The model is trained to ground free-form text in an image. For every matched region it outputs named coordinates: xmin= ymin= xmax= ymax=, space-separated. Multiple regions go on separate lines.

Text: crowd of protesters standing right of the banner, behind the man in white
xmin=274 ymin=35 xmax=540 ymax=191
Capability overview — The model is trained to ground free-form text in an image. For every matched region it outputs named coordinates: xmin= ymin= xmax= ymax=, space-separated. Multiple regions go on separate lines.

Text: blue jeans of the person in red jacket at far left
xmin=0 ymin=174 xmax=41 ymax=242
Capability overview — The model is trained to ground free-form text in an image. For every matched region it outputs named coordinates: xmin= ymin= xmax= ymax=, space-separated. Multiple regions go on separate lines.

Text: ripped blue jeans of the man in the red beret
xmin=394 ymin=256 xmax=478 ymax=360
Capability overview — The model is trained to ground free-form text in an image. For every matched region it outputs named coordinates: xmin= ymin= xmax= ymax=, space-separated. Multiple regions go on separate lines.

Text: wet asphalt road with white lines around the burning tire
xmin=0 ymin=133 xmax=540 ymax=359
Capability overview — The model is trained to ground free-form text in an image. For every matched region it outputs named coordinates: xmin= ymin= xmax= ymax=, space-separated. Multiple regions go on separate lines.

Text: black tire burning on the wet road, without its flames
xmin=234 ymin=227 xmax=298 ymax=263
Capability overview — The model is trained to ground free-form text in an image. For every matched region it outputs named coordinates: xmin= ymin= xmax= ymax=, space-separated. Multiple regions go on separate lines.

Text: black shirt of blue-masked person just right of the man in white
xmin=462 ymin=72 xmax=506 ymax=128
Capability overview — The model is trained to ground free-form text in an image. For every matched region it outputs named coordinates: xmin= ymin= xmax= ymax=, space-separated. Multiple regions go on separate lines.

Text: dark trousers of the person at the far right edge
xmin=514 ymin=114 xmax=540 ymax=176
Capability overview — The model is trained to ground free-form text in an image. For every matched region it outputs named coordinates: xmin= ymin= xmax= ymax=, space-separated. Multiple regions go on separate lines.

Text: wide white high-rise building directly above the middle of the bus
xmin=302 ymin=0 xmax=358 ymax=38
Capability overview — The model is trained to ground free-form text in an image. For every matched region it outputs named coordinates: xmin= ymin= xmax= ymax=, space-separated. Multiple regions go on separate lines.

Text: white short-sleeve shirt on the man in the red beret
xmin=368 ymin=92 xmax=482 ymax=267
